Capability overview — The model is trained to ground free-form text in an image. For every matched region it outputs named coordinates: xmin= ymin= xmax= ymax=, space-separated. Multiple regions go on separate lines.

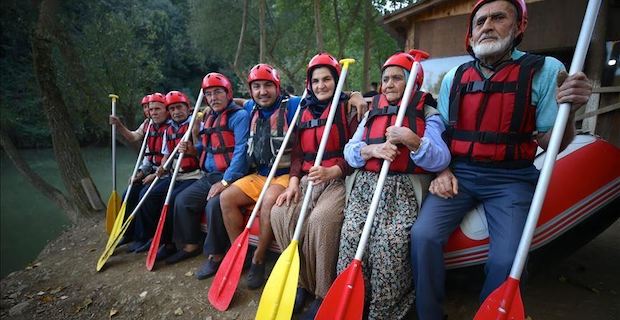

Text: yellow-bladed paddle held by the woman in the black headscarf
xmin=256 ymin=59 xmax=355 ymax=319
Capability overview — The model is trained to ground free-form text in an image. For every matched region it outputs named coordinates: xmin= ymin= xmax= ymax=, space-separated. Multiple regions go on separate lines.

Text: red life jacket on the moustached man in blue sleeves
xmin=200 ymin=105 xmax=241 ymax=172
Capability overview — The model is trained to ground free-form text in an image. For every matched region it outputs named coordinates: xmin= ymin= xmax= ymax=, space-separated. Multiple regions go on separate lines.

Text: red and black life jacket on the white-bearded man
xmin=446 ymin=54 xmax=545 ymax=168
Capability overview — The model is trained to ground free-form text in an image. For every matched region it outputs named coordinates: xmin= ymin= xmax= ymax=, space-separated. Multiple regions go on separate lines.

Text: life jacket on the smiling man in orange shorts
xmin=247 ymin=98 xmax=294 ymax=169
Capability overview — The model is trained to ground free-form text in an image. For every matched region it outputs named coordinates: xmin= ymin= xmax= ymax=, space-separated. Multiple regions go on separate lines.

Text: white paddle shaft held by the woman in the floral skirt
xmin=355 ymin=60 xmax=420 ymax=261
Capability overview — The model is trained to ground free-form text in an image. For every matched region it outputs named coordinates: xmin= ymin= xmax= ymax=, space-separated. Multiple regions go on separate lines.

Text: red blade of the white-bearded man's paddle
xmin=474 ymin=278 xmax=525 ymax=320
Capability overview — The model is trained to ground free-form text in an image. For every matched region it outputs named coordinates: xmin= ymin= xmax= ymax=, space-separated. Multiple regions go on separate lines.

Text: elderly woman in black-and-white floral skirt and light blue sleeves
xmin=338 ymin=52 xmax=450 ymax=319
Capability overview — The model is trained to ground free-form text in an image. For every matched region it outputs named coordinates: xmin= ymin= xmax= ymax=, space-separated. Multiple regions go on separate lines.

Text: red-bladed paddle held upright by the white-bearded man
xmin=474 ymin=0 xmax=601 ymax=320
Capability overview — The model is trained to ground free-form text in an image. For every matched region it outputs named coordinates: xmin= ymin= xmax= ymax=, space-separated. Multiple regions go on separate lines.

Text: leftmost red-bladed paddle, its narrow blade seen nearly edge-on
xmin=146 ymin=88 xmax=204 ymax=271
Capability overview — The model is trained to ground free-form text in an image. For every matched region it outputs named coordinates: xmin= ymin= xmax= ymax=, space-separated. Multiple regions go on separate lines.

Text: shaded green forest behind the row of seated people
xmin=0 ymin=0 xmax=413 ymax=148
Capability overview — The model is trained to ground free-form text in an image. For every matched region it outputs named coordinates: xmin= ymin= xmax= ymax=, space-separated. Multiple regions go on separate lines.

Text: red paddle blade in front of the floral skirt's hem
xmin=314 ymin=260 xmax=365 ymax=320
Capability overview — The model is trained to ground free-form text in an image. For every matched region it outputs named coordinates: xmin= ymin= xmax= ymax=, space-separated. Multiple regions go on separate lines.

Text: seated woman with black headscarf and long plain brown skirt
xmin=271 ymin=53 xmax=357 ymax=319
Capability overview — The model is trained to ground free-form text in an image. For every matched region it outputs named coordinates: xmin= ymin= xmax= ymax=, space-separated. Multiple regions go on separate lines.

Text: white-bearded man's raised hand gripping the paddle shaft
xmin=556 ymin=71 xmax=592 ymax=113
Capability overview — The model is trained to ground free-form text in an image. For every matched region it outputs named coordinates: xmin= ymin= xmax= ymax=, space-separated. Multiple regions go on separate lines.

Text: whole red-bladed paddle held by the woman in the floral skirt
xmin=315 ymin=50 xmax=429 ymax=320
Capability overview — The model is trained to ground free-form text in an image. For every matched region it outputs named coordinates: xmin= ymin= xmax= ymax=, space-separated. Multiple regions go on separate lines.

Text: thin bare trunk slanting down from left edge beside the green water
xmin=0 ymin=129 xmax=78 ymax=223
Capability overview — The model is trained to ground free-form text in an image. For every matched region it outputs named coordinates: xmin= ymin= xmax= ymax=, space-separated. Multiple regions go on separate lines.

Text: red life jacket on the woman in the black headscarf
xmin=298 ymin=103 xmax=350 ymax=172
